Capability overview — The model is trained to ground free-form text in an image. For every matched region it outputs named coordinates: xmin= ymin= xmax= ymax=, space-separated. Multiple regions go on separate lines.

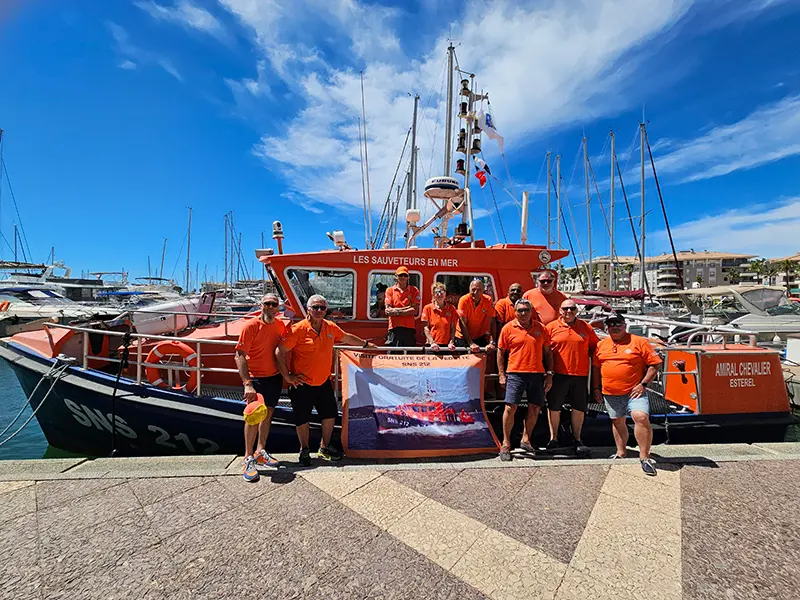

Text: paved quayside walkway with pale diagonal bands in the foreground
xmin=0 ymin=444 xmax=800 ymax=600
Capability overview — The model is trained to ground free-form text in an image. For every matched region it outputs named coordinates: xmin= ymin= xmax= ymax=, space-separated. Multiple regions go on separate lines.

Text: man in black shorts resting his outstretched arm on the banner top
xmin=276 ymin=294 xmax=374 ymax=467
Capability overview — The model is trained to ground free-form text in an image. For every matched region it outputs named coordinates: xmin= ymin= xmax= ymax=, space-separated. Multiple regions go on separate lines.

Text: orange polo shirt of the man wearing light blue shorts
xmin=594 ymin=334 xmax=661 ymax=396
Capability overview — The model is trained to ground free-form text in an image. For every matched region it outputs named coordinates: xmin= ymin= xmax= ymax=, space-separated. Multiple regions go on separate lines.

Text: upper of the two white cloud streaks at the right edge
xmin=658 ymin=95 xmax=800 ymax=181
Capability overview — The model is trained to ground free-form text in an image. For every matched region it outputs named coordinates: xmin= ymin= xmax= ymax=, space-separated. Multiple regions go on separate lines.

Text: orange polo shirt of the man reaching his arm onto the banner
xmin=281 ymin=319 xmax=345 ymax=386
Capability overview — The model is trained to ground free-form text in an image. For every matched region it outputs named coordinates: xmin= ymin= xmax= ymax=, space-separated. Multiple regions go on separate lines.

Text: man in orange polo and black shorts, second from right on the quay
xmin=546 ymin=298 xmax=600 ymax=454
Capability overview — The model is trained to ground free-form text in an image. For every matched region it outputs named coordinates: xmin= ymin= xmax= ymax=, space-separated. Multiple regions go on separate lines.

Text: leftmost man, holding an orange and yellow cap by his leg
xmin=234 ymin=294 xmax=286 ymax=482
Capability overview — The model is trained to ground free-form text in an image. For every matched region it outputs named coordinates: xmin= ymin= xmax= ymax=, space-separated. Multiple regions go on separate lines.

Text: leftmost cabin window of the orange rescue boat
xmin=286 ymin=269 xmax=355 ymax=321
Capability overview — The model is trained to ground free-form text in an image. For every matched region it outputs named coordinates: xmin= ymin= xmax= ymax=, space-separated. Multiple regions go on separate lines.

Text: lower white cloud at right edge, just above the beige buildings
xmin=653 ymin=197 xmax=800 ymax=257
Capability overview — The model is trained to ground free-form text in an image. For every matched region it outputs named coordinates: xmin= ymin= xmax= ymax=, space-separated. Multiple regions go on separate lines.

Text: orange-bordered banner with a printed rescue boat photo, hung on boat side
xmin=340 ymin=352 xmax=499 ymax=458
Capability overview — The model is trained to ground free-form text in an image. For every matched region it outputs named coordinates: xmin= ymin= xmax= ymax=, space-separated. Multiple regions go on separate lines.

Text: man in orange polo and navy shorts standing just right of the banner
xmin=497 ymin=298 xmax=553 ymax=461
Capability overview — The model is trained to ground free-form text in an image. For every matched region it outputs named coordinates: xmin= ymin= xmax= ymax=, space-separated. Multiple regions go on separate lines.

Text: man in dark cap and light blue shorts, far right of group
xmin=592 ymin=315 xmax=661 ymax=475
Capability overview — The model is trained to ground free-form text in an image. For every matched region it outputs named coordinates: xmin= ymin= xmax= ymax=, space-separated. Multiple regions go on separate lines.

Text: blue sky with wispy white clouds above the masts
xmin=0 ymin=0 xmax=800 ymax=286
